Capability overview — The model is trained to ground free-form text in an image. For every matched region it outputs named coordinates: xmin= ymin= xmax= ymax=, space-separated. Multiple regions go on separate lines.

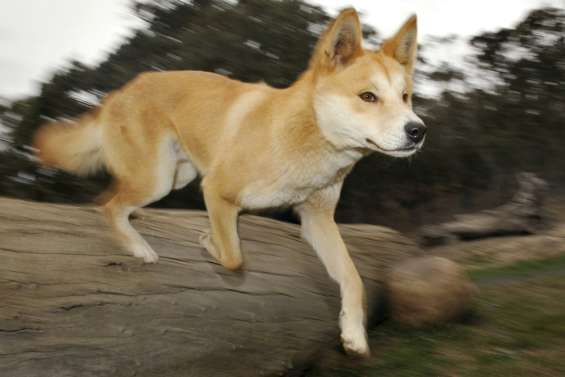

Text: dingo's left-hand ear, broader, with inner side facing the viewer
xmin=310 ymin=8 xmax=363 ymax=71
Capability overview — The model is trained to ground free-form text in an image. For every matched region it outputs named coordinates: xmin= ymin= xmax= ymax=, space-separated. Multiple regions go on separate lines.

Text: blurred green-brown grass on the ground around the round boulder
xmin=308 ymin=255 xmax=565 ymax=377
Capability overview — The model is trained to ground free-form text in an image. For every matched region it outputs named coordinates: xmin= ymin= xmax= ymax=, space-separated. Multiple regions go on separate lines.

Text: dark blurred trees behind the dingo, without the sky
xmin=0 ymin=0 xmax=565 ymax=228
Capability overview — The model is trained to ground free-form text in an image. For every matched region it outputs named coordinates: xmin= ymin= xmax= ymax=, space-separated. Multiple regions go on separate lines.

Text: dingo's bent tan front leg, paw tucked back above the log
xmin=200 ymin=187 xmax=243 ymax=270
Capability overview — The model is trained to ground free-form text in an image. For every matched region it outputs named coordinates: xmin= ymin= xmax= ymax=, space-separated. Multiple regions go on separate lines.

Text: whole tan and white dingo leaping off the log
xmin=35 ymin=9 xmax=425 ymax=355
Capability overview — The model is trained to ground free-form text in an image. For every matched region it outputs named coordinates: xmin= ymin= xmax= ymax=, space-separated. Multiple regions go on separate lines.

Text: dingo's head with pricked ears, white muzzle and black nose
xmin=310 ymin=9 xmax=426 ymax=157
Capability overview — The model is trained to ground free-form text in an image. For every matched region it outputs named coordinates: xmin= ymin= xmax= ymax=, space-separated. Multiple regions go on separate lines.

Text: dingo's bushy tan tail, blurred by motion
xmin=33 ymin=111 xmax=105 ymax=176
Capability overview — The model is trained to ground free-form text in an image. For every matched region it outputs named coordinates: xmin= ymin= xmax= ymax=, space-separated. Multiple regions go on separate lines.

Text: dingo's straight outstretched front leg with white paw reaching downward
xmin=297 ymin=183 xmax=369 ymax=356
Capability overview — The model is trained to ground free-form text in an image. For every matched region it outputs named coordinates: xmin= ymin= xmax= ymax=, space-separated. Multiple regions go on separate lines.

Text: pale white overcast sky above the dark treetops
xmin=0 ymin=0 xmax=565 ymax=99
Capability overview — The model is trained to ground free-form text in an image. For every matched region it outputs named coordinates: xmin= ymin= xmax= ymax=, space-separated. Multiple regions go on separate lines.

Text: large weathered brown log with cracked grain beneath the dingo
xmin=0 ymin=198 xmax=418 ymax=377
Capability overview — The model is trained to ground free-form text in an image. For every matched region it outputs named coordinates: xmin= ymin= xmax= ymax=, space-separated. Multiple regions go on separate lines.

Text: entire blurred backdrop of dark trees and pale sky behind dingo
xmin=0 ymin=0 xmax=565 ymax=232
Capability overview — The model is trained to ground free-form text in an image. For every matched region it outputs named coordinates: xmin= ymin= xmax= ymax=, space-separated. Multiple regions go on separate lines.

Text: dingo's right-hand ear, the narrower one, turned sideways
xmin=381 ymin=15 xmax=418 ymax=72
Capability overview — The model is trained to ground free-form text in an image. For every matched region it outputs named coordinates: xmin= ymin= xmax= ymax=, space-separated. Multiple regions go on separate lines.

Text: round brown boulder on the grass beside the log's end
xmin=387 ymin=256 xmax=477 ymax=326
